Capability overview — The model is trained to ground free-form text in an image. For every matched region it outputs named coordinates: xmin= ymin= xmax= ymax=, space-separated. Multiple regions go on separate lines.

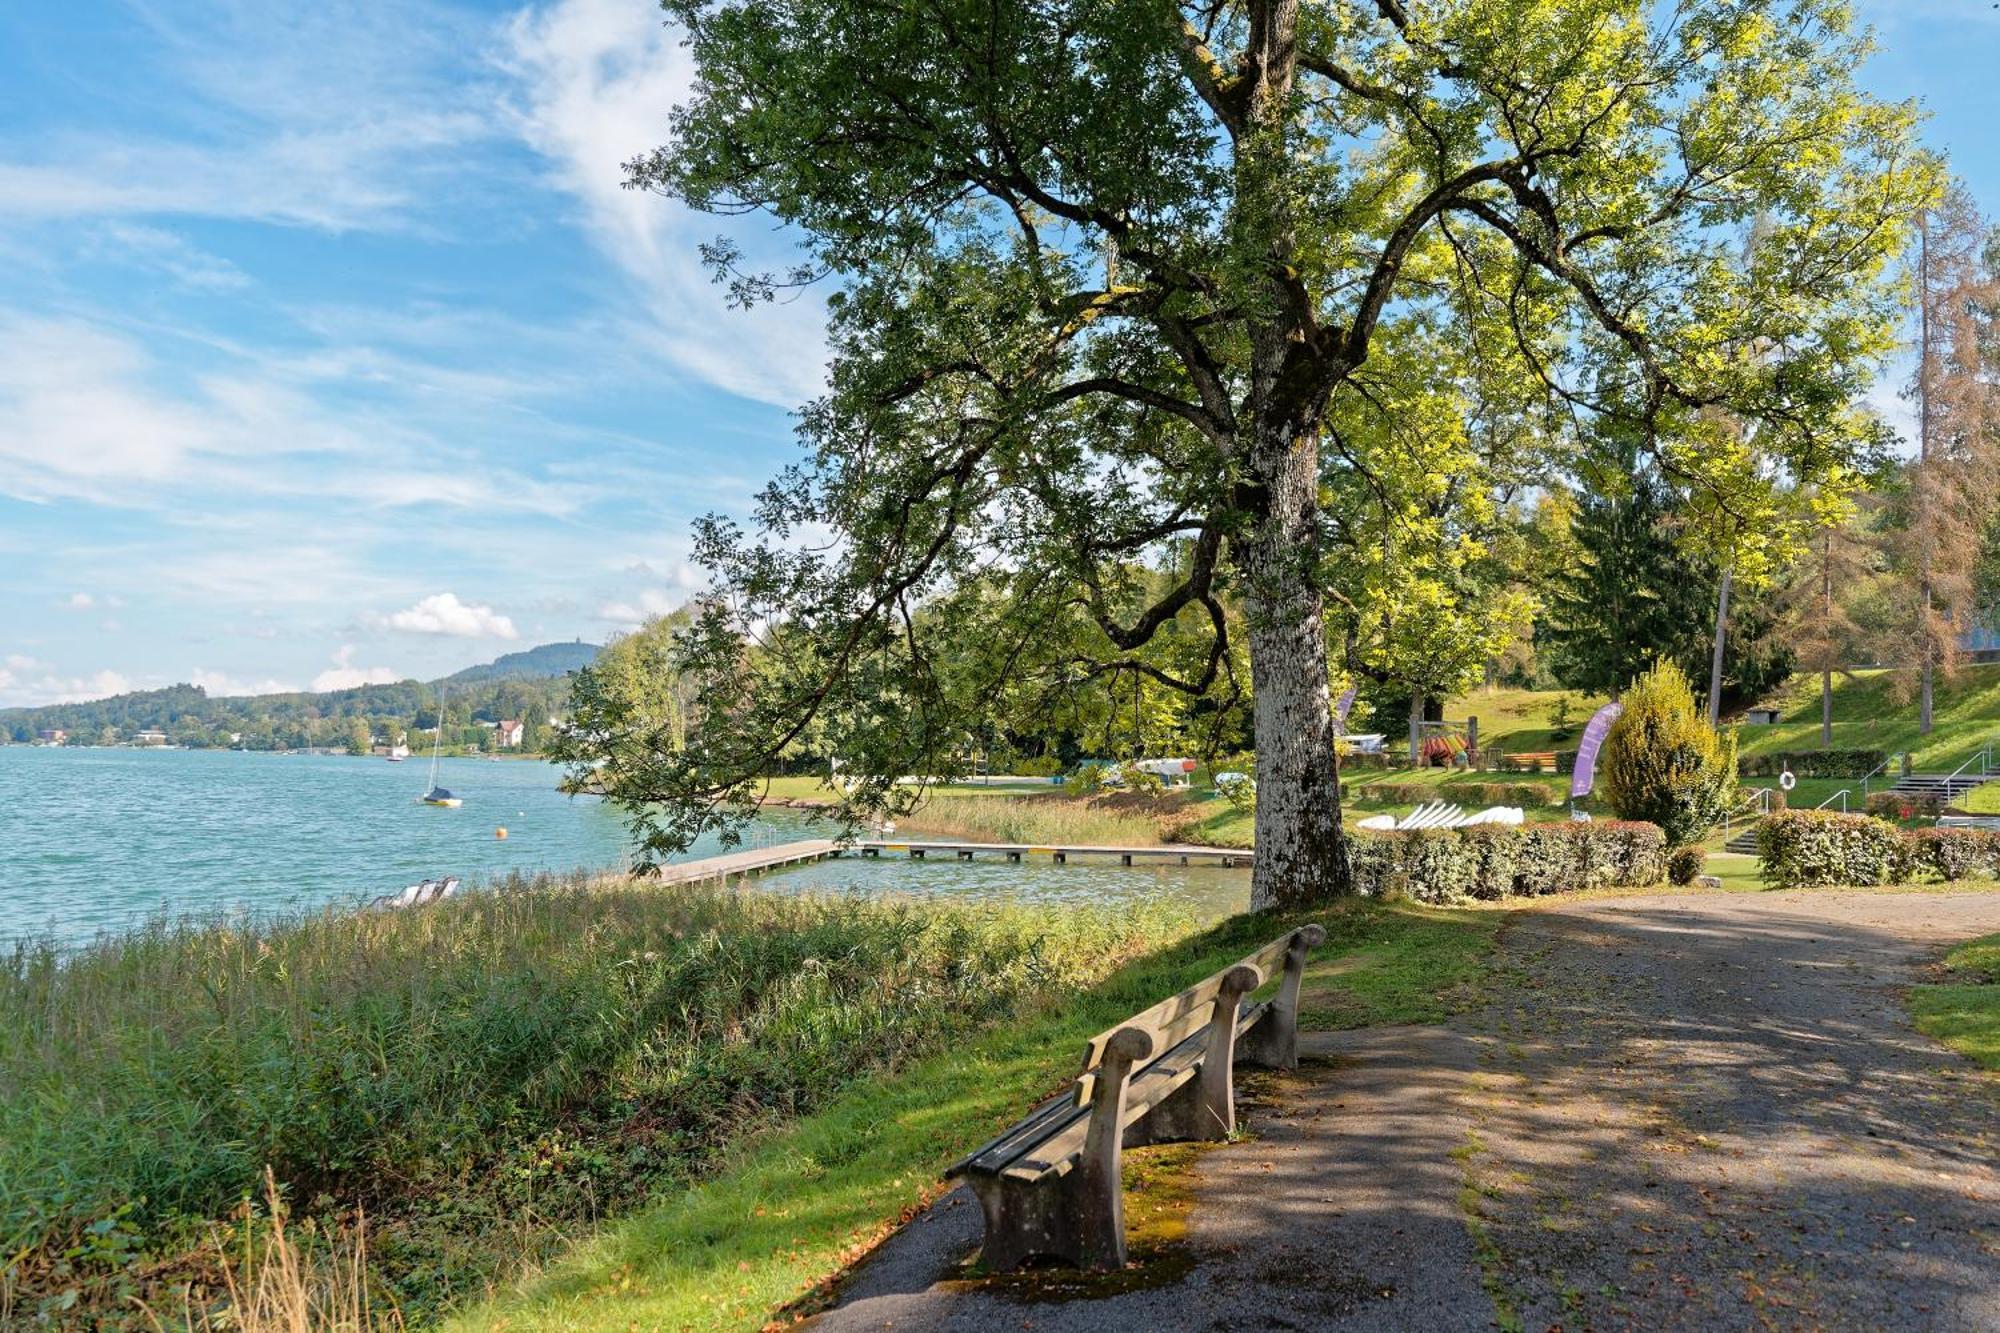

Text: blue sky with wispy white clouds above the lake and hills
xmin=0 ymin=0 xmax=2000 ymax=707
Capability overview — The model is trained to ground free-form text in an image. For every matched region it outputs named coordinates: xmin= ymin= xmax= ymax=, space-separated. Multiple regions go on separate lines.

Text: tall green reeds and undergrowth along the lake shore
xmin=0 ymin=881 xmax=1192 ymax=1325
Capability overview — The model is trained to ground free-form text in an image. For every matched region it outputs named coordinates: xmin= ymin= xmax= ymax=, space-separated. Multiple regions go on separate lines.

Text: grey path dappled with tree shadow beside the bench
xmin=816 ymin=893 xmax=2000 ymax=1333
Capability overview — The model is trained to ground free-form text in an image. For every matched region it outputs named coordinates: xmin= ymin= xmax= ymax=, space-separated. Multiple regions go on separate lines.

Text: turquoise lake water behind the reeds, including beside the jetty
xmin=0 ymin=745 xmax=1250 ymax=943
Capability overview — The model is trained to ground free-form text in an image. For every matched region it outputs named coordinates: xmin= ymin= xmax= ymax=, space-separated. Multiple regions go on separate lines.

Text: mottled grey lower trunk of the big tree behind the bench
xmin=1236 ymin=426 xmax=1350 ymax=911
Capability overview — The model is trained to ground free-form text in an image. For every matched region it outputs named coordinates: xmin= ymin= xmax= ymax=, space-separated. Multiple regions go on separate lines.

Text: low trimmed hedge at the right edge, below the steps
xmin=1756 ymin=811 xmax=2000 ymax=889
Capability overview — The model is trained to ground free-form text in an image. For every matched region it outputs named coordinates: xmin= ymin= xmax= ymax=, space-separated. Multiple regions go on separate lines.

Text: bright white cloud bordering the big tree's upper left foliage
xmin=504 ymin=0 xmax=826 ymax=406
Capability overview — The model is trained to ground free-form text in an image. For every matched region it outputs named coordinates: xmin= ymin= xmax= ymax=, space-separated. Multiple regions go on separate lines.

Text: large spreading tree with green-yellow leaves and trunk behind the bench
xmin=618 ymin=0 xmax=1932 ymax=905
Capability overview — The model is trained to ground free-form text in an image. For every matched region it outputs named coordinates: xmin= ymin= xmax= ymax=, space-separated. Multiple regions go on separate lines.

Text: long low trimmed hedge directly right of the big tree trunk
xmin=1346 ymin=821 xmax=1666 ymax=903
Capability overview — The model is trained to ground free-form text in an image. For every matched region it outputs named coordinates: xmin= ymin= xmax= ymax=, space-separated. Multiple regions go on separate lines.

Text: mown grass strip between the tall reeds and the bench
xmin=454 ymin=901 xmax=1506 ymax=1333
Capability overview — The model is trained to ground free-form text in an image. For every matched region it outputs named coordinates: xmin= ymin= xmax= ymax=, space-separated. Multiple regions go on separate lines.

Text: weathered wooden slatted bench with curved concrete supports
xmin=944 ymin=925 xmax=1326 ymax=1273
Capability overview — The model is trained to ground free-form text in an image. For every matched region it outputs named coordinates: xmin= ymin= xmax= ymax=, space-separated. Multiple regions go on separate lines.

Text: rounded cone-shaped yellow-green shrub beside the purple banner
xmin=1604 ymin=660 xmax=1736 ymax=847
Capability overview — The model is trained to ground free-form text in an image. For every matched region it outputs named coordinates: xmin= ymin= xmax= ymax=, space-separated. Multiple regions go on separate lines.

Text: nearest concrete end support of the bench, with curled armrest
xmin=970 ymin=1027 xmax=1152 ymax=1273
